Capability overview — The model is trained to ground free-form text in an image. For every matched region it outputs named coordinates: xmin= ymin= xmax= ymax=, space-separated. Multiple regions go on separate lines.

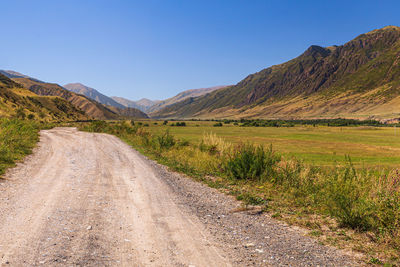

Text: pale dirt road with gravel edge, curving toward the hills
xmin=0 ymin=128 xmax=352 ymax=266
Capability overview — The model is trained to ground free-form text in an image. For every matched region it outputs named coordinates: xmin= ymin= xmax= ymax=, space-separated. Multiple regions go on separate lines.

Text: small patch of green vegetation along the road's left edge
xmin=0 ymin=118 xmax=39 ymax=178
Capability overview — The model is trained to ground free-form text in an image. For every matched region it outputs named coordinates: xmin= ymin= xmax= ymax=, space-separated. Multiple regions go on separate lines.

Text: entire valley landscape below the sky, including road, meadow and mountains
xmin=0 ymin=26 xmax=400 ymax=266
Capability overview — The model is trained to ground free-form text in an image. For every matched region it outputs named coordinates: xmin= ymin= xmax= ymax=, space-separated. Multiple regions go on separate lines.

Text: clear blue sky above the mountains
xmin=0 ymin=0 xmax=400 ymax=99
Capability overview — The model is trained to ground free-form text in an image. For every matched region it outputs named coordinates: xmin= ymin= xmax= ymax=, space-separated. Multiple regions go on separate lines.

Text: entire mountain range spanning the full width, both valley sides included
xmin=0 ymin=26 xmax=400 ymax=120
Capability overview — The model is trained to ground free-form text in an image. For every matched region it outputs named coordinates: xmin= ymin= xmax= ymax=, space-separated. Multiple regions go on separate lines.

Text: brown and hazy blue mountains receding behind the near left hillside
xmin=0 ymin=70 xmax=224 ymax=119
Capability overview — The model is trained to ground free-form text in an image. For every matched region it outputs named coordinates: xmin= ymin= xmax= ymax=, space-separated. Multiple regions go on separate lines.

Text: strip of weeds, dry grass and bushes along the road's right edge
xmin=81 ymin=121 xmax=400 ymax=264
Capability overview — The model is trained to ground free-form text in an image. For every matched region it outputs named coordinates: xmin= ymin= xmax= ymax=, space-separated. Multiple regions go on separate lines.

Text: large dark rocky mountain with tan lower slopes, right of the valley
xmin=152 ymin=26 xmax=400 ymax=118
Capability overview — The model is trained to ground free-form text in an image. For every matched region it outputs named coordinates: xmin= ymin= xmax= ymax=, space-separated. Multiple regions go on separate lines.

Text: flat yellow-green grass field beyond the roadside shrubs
xmin=141 ymin=121 xmax=400 ymax=168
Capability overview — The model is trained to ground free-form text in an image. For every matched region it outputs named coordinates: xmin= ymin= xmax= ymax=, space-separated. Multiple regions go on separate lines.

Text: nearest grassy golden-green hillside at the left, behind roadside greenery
xmin=0 ymin=74 xmax=88 ymax=121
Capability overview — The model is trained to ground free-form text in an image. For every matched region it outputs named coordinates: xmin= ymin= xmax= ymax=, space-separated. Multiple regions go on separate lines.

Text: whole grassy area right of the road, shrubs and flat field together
xmin=80 ymin=120 xmax=400 ymax=266
